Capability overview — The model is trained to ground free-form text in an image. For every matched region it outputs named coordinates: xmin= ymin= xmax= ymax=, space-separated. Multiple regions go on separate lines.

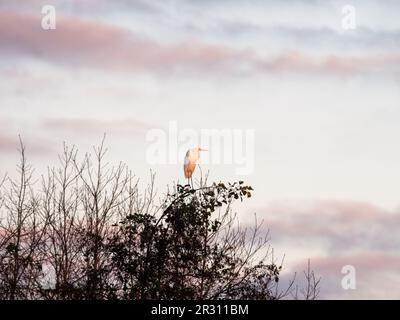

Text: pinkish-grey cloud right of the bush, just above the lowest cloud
xmin=256 ymin=199 xmax=400 ymax=254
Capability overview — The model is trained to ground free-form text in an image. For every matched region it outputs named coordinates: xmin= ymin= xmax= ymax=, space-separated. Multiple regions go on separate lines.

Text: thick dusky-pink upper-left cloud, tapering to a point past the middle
xmin=0 ymin=12 xmax=239 ymax=69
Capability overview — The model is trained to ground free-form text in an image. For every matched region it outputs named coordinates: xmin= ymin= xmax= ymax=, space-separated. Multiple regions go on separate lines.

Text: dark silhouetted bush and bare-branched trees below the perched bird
xmin=0 ymin=143 xmax=319 ymax=299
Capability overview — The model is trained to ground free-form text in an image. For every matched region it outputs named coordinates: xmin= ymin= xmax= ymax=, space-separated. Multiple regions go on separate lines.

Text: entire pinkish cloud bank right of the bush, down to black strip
xmin=257 ymin=199 xmax=400 ymax=299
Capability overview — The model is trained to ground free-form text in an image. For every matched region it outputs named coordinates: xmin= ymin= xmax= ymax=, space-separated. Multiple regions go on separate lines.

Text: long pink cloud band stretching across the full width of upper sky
xmin=0 ymin=11 xmax=400 ymax=74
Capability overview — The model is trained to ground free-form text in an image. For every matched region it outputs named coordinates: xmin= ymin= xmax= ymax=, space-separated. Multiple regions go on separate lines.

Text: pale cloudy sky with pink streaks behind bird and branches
xmin=0 ymin=0 xmax=400 ymax=298
